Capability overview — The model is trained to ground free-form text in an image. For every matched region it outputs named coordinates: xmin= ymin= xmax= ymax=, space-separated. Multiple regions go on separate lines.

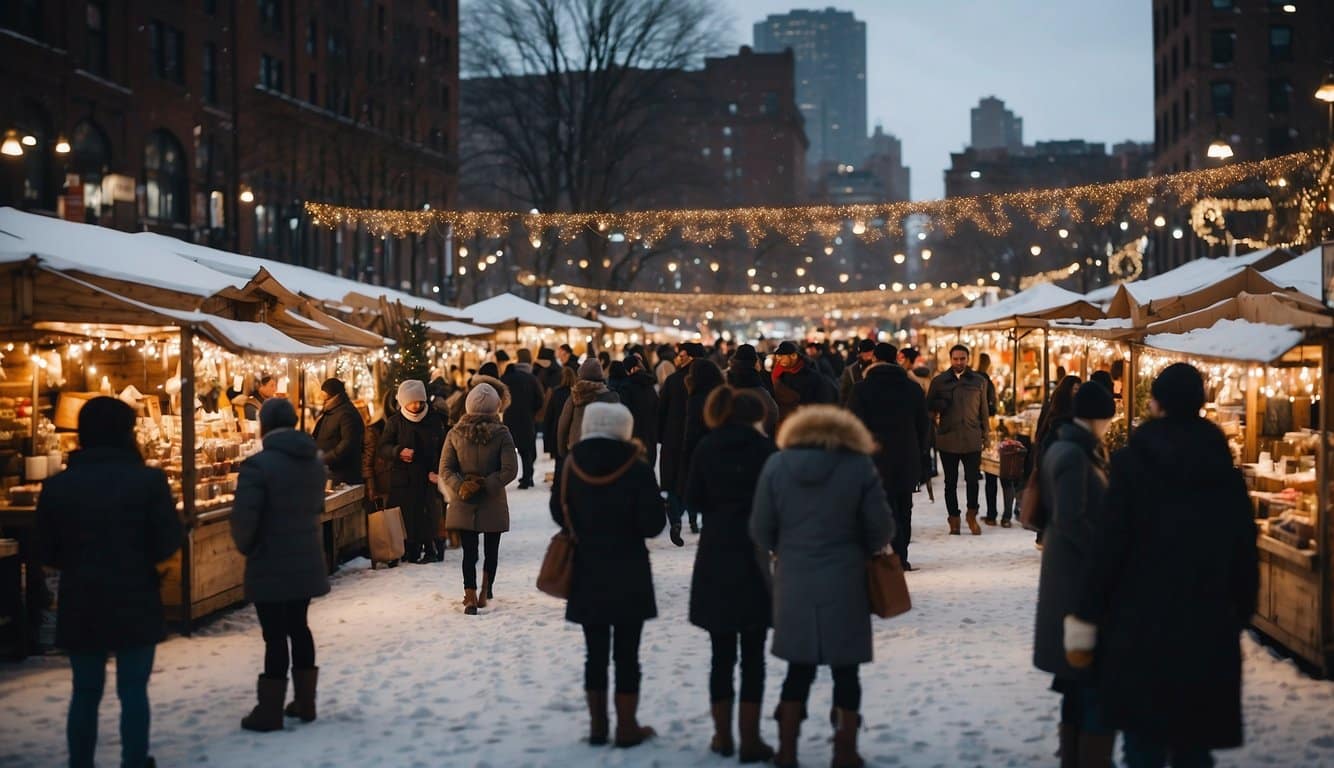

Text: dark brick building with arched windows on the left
xmin=0 ymin=0 xmax=459 ymax=292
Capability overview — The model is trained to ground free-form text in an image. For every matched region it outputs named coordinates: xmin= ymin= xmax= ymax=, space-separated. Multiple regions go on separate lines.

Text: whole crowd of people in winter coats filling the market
xmin=37 ymin=340 xmax=1258 ymax=768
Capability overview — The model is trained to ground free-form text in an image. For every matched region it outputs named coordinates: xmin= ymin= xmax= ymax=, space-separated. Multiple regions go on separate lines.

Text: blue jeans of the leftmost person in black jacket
xmin=65 ymin=645 xmax=157 ymax=768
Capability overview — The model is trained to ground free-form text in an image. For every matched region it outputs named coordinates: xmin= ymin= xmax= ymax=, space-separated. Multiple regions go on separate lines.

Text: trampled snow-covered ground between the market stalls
xmin=0 ymin=464 xmax=1334 ymax=767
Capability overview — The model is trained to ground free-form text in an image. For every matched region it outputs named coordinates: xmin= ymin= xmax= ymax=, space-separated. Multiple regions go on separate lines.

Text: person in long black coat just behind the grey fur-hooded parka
xmin=848 ymin=344 xmax=931 ymax=571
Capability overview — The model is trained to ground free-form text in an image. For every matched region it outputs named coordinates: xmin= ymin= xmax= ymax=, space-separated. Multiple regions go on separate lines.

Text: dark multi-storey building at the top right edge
xmin=1149 ymin=0 xmax=1334 ymax=272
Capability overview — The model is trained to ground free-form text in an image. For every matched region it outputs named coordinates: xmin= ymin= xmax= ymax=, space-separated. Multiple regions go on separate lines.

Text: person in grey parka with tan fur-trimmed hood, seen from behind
xmin=750 ymin=405 xmax=894 ymax=765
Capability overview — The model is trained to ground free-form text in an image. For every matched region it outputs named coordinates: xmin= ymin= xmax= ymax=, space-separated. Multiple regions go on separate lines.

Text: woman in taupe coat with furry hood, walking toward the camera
xmin=439 ymin=383 xmax=519 ymax=616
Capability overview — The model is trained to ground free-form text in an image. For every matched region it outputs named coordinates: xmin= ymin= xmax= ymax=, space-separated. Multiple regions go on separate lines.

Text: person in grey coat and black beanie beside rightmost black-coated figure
xmin=1033 ymin=383 xmax=1117 ymax=767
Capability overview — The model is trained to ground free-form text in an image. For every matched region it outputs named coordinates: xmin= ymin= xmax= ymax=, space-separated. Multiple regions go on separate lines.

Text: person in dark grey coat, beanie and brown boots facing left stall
xmin=231 ymin=399 xmax=329 ymax=732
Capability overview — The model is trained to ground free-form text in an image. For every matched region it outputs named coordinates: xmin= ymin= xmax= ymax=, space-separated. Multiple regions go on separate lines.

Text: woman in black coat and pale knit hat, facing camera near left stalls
xmin=380 ymin=379 xmax=446 ymax=563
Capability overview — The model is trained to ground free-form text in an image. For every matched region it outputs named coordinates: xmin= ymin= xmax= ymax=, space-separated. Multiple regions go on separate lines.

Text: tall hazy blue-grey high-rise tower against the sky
xmin=755 ymin=8 xmax=866 ymax=177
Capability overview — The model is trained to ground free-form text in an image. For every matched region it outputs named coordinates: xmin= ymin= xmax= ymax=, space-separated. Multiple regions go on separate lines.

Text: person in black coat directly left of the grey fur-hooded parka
xmin=686 ymin=387 xmax=778 ymax=763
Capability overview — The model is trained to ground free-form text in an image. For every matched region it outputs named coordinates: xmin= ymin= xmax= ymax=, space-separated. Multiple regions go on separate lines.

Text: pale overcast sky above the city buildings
xmin=720 ymin=0 xmax=1154 ymax=200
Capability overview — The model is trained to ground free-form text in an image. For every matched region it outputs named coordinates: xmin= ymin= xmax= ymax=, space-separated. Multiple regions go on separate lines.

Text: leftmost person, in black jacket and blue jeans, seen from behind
xmin=36 ymin=397 xmax=181 ymax=765
